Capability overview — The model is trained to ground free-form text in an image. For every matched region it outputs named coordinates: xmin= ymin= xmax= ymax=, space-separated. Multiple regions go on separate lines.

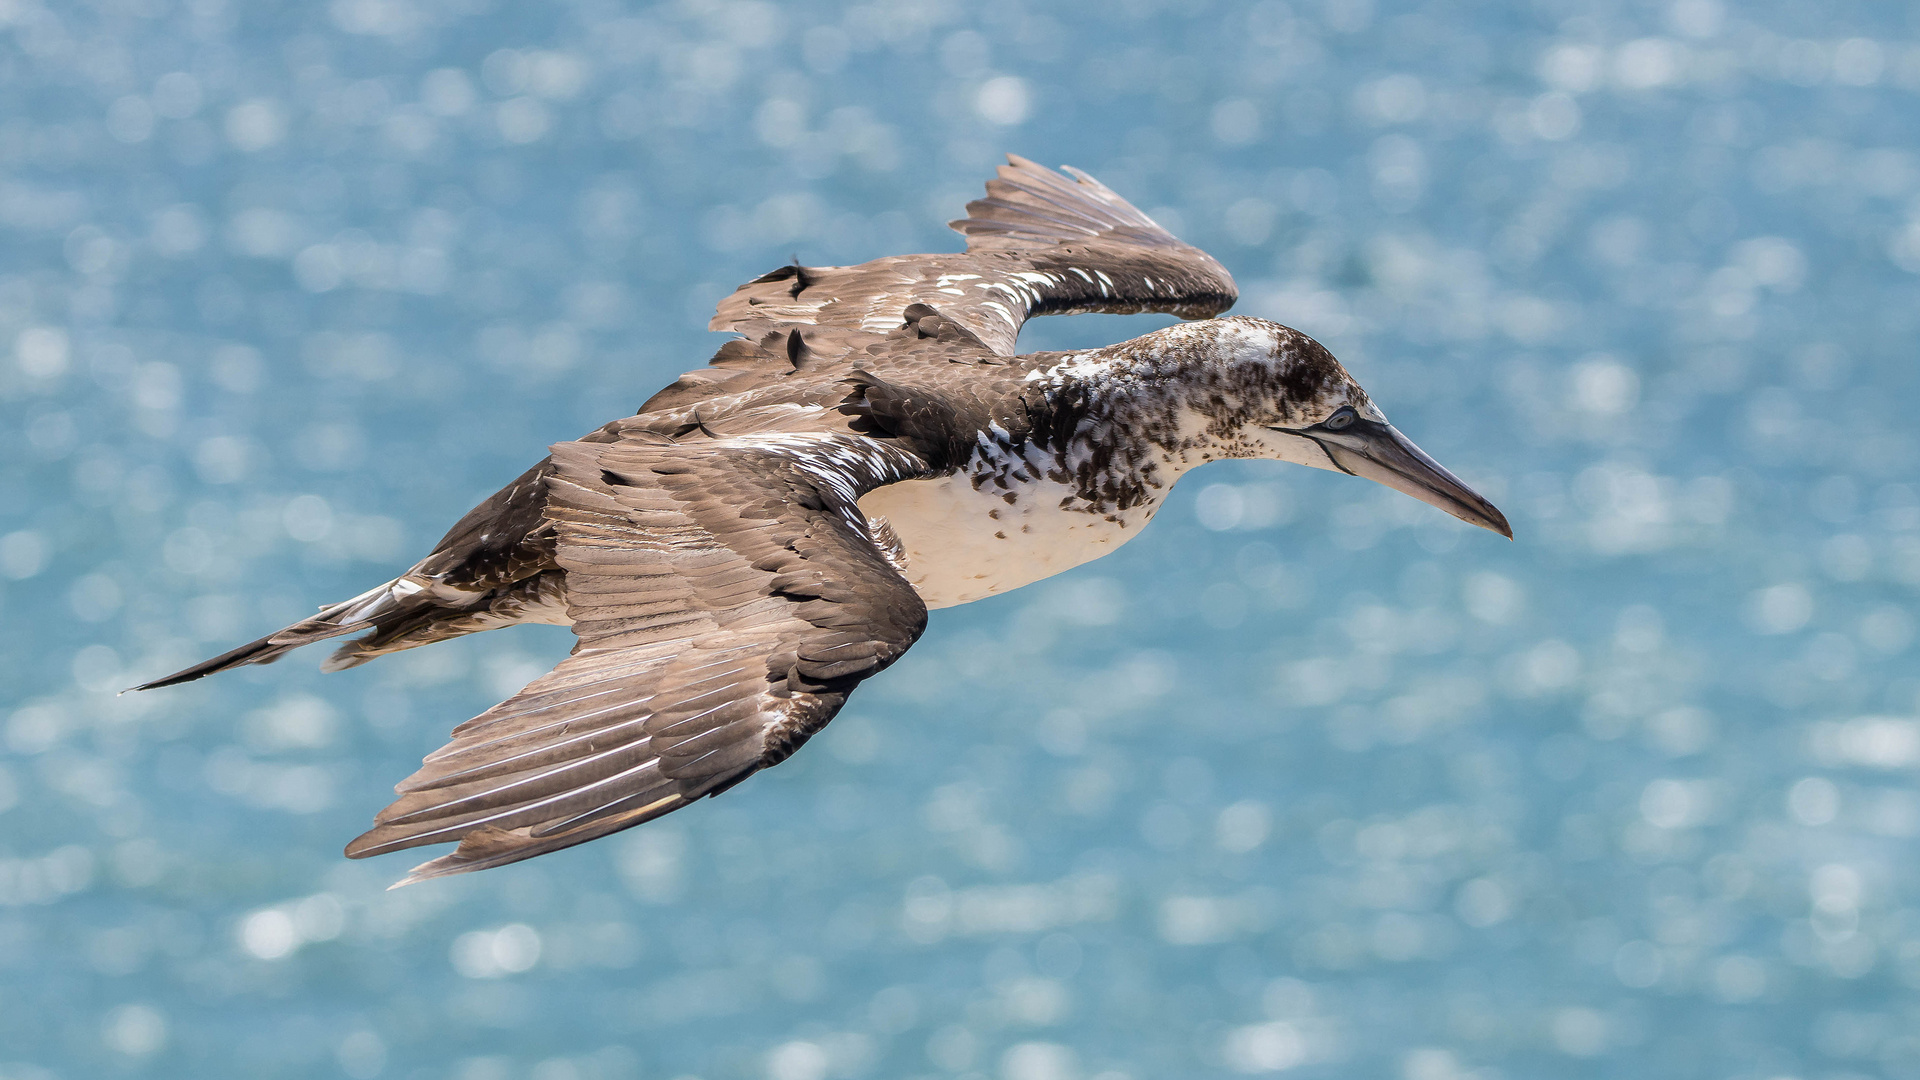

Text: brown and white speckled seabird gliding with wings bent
xmin=136 ymin=156 xmax=1513 ymax=884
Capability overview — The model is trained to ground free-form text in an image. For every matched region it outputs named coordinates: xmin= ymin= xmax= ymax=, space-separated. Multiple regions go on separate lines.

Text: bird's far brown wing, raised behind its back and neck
xmin=707 ymin=154 xmax=1238 ymax=356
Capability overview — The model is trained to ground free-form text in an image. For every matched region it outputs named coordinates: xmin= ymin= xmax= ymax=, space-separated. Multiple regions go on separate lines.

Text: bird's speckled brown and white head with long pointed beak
xmin=1128 ymin=315 xmax=1513 ymax=540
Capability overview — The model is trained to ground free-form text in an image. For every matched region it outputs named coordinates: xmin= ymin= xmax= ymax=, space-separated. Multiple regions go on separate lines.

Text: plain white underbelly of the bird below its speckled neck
xmin=860 ymin=475 xmax=1154 ymax=607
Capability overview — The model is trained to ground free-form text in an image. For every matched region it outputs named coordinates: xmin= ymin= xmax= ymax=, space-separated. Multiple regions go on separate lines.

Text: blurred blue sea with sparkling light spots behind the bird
xmin=0 ymin=0 xmax=1920 ymax=1080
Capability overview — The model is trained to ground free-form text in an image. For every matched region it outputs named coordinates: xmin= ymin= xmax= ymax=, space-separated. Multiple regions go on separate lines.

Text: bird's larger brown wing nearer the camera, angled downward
xmin=348 ymin=424 xmax=927 ymax=882
